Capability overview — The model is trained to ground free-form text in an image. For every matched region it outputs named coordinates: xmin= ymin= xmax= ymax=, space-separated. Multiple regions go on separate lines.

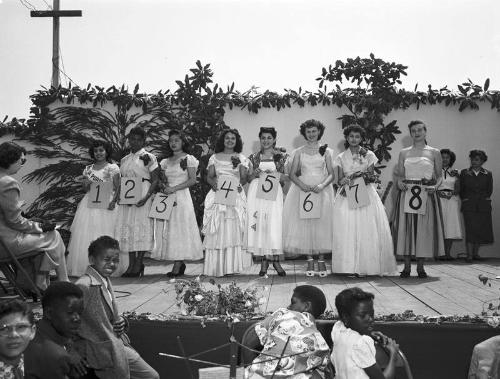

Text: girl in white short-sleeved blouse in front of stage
xmin=332 ymin=287 xmax=398 ymax=379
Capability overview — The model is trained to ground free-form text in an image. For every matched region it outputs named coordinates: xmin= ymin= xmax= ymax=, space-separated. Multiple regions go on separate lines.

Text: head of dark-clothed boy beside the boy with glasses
xmin=42 ymin=282 xmax=83 ymax=338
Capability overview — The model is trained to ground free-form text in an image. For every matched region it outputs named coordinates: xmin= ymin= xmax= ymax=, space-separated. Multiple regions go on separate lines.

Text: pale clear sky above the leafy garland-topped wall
xmin=0 ymin=0 xmax=500 ymax=120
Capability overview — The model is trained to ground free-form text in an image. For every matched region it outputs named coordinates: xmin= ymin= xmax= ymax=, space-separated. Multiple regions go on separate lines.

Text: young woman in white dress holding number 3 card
xmin=151 ymin=130 xmax=203 ymax=277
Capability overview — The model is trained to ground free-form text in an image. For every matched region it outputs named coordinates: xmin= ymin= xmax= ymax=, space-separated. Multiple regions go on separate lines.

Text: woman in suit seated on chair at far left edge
xmin=0 ymin=142 xmax=69 ymax=290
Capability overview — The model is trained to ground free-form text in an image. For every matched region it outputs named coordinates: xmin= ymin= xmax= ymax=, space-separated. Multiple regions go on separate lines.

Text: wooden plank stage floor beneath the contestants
xmin=112 ymin=259 xmax=500 ymax=316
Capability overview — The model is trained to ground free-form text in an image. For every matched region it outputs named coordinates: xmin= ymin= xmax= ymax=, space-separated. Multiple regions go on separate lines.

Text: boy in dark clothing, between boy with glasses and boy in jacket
xmin=25 ymin=282 xmax=92 ymax=379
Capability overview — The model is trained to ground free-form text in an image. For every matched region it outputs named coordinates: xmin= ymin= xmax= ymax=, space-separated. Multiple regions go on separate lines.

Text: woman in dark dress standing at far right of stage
xmin=460 ymin=150 xmax=493 ymax=262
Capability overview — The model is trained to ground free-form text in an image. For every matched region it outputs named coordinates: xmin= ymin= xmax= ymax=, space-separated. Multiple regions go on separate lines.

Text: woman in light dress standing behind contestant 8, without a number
xmin=437 ymin=149 xmax=463 ymax=261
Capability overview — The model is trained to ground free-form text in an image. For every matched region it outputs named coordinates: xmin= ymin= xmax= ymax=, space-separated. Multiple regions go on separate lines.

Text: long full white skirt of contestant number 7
xmin=332 ymin=185 xmax=397 ymax=275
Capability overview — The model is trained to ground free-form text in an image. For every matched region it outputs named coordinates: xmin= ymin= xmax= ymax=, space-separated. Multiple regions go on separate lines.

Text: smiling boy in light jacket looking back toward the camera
xmin=76 ymin=236 xmax=159 ymax=379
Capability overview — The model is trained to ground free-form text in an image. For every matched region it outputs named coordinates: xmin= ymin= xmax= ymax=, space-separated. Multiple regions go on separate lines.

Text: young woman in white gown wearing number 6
xmin=283 ymin=120 xmax=334 ymax=277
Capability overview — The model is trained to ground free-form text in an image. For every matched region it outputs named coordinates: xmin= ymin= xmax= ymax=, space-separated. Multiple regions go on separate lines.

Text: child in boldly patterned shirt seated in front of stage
xmin=245 ymin=285 xmax=330 ymax=379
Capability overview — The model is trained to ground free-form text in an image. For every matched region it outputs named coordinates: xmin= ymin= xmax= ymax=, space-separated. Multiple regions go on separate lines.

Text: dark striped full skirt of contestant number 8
xmin=392 ymin=191 xmax=444 ymax=258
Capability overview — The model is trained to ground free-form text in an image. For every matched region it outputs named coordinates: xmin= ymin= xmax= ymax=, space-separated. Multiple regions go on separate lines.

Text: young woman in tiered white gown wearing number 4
xmin=202 ymin=129 xmax=252 ymax=276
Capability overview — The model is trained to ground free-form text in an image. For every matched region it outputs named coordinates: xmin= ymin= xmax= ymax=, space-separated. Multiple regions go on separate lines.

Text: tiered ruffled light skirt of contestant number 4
xmin=202 ymin=190 xmax=252 ymax=276
